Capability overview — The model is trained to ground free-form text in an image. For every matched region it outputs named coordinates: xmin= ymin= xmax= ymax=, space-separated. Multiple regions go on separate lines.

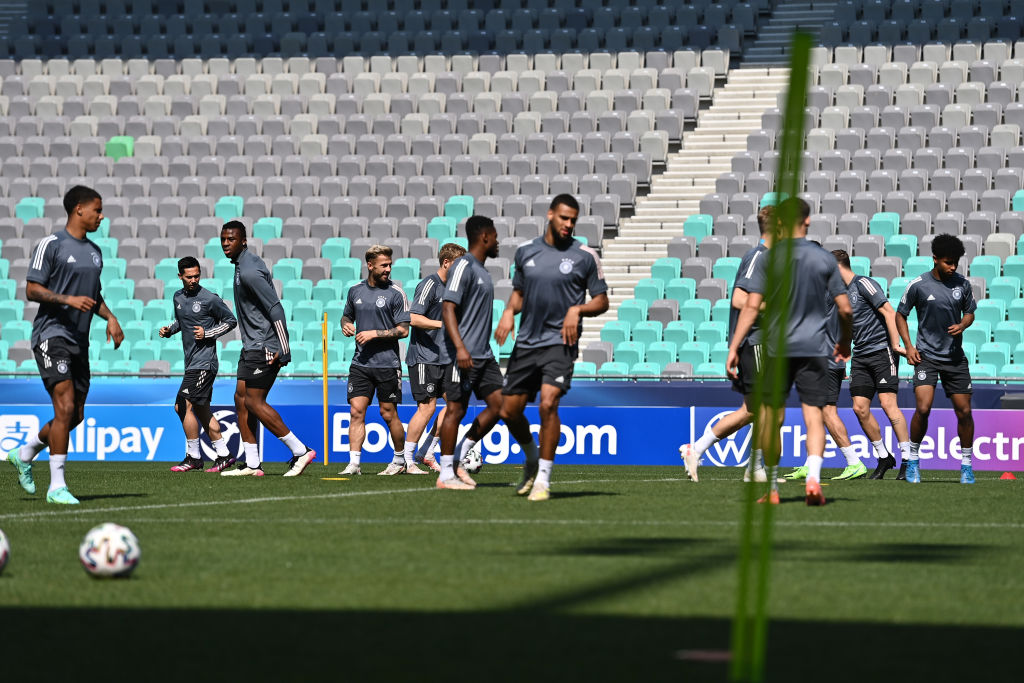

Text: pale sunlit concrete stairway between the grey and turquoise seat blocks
xmin=581 ymin=69 xmax=790 ymax=346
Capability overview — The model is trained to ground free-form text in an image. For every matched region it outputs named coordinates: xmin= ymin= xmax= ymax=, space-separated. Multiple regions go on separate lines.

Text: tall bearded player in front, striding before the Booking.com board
xmin=495 ymin=195 xmax=608 ymax=501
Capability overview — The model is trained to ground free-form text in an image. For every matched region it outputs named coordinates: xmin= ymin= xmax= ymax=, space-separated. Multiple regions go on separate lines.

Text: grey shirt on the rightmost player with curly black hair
xmin=896 ymin=270 xmax=978 ymax=360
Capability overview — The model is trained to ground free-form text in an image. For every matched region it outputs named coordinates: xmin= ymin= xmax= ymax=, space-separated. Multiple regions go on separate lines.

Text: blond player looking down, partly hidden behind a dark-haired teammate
xmin=406 ymin=243 xmax=466 ymax=474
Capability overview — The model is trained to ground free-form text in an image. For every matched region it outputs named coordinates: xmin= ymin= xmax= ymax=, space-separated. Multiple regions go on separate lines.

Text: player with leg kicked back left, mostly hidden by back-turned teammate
xmin=679 ymin=206 xmax=776 ymax=482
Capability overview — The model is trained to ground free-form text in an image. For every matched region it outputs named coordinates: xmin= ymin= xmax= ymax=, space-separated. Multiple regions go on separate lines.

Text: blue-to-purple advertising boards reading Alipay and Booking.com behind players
xmin=0 ymin=378 xmax=1024 ymax=471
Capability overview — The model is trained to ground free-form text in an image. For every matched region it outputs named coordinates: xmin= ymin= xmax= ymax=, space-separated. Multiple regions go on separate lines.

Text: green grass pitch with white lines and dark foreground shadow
xmin=0 ymin=462 xmax=1024 ymax=683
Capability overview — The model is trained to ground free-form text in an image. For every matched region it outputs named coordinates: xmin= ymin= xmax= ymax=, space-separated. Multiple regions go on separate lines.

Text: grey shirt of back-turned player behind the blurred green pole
xmin=751 ymin=238 xmax=846 ymax=358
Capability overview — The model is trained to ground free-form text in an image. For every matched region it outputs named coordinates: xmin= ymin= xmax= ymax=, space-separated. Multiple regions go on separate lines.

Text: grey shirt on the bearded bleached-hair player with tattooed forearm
xmin=343 ymin=280 xmax=409 ymax=368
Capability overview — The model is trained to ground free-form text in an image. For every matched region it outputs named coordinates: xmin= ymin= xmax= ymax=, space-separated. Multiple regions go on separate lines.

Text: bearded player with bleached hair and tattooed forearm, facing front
xmin=341 ymin=245 xmax=411 ymax=476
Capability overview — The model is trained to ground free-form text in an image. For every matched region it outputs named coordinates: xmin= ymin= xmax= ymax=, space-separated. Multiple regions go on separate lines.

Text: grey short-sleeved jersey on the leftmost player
xmin=26 ymin=229 xmax=103 ymax=350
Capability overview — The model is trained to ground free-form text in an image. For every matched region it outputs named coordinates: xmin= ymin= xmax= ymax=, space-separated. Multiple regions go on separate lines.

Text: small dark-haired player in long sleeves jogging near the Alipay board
xmin=160 ymin=256 xmax=238 ymax=472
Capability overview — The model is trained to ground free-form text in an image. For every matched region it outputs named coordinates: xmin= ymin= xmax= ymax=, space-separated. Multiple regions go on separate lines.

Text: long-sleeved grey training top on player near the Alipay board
xmin=167 ymin=287 xmax=238 ymax=372
